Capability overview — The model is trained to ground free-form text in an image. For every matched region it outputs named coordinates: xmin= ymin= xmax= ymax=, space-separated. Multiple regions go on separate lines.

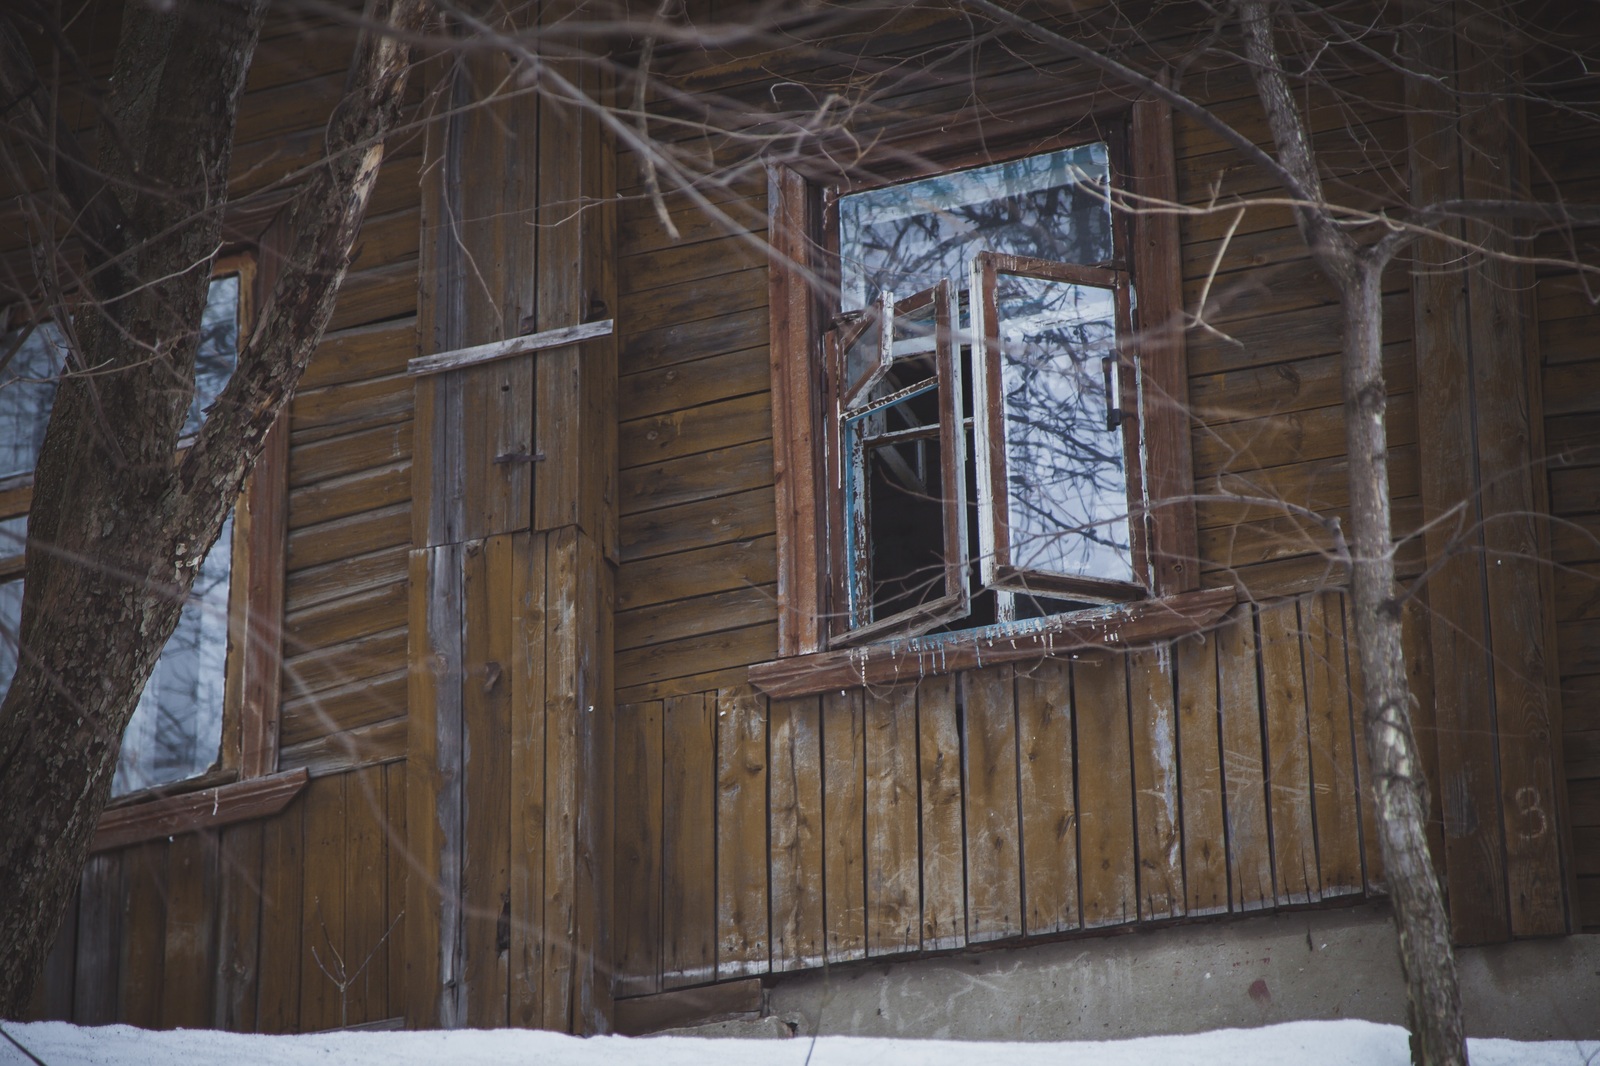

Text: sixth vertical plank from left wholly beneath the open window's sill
xmin=1016 ymin=659 xmax=1080 ymax=936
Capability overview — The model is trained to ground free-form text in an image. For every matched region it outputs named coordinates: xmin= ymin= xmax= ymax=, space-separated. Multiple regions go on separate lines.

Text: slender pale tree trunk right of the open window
xmin=1238 ymin=0 xmax=1467 ymax=1066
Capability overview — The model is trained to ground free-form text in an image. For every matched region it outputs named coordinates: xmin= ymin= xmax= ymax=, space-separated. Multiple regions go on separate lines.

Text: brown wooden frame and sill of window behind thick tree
xmin=0 ymin=253 xmax=309 ymax=852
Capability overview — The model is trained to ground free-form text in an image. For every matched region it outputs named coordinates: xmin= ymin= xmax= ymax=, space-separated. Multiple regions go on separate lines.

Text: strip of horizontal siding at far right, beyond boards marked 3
xmin=1528 ymin=37 xmax=1600 ymax=933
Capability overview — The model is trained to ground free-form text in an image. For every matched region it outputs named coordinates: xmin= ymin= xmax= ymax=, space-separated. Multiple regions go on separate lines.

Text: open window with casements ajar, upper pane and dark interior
xmin=822 ymin=141 xmax=1150 ymax=645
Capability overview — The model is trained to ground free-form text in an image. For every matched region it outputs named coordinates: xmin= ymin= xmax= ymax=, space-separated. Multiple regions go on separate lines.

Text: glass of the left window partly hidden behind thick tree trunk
xmin=0 ymin=262 xmax=282 ymax=795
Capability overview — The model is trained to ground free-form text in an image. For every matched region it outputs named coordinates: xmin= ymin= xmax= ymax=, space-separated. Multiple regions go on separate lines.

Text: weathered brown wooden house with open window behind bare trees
xmin=0 ymin=0 xmax=1600 ymax=1032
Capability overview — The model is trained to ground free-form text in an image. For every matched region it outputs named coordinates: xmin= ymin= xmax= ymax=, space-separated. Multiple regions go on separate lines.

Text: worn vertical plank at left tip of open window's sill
xmin=717 ymin=687 xmax=771 ymax=981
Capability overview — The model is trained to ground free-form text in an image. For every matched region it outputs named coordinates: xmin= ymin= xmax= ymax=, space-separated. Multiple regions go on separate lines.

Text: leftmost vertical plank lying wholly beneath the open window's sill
xmin=768 ymin=696 xmax=824 ymax=972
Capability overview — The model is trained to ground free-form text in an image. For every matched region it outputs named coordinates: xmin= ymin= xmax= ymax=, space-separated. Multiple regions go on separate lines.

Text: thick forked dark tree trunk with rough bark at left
xmin=0 ymin=0 xmax=427 ymax=1018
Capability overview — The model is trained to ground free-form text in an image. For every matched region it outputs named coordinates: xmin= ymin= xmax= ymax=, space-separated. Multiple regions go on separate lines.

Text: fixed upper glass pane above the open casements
xmin=838 ymin=144 xmax=1112 ymax=311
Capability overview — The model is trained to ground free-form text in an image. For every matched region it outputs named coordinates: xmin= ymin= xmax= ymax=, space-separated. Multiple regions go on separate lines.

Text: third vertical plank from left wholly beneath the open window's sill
xmin=862 ymin=683 xmax=922 ymax=956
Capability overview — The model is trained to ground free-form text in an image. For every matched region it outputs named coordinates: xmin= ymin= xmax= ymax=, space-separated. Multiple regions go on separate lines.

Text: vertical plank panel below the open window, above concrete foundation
xmin=604 ymin=592 xmax=1382 ymax=997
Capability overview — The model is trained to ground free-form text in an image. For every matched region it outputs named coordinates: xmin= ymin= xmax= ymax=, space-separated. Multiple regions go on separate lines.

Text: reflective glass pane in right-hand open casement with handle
xmin=995 ymin=265 xmax=1133 ymax=581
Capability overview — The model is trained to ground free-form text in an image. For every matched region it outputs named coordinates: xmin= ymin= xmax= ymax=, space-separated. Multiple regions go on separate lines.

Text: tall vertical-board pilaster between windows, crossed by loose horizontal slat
xmin=406 ymin=0 xmax=616 ymax=1032
